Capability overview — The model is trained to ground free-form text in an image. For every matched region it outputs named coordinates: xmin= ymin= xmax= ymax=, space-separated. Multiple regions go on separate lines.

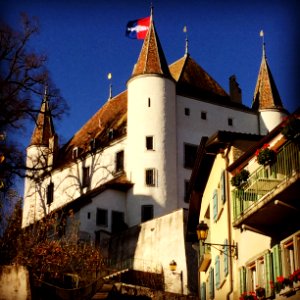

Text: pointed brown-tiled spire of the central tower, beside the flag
xmin=132 ymin=10 xmax=171 ymax=77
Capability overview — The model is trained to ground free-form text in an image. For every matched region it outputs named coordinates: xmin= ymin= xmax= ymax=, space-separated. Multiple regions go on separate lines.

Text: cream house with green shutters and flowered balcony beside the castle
xmin=187 ymin=116 xmax=300 ymax=299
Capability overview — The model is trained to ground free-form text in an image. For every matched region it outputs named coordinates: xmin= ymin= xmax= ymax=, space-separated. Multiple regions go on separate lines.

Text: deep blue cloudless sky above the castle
xmin=0 ymin=0 xmax=300 ymax=144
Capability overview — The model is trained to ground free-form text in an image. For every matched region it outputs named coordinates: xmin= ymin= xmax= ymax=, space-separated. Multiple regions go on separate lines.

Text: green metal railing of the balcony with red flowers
xmin=232 ymin=142 xmax=300 ymax=221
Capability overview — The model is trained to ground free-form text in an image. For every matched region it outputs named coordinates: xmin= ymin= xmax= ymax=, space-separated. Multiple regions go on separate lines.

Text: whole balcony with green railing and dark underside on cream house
xmin=232 ymin=143 xmax=300 ymax=236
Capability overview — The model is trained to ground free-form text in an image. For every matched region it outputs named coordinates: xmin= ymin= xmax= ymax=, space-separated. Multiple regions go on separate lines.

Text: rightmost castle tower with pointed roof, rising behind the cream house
xmin=252 ymin=36 xmax=287 ymax=134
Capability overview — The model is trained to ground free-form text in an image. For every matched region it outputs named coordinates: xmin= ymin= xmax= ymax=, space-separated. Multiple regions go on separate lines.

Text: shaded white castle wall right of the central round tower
xmin=176 ymin=96 xmax=259 ymax=208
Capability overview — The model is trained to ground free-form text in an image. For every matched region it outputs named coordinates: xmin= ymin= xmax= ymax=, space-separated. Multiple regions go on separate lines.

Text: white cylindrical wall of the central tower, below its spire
xmin=126 ymin=75 xmax=177 ymax=226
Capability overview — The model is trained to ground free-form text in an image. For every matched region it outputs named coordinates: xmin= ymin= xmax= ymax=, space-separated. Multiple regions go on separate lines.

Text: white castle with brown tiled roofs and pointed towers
xmin=22 ymin=15 xmax=286 ymax=241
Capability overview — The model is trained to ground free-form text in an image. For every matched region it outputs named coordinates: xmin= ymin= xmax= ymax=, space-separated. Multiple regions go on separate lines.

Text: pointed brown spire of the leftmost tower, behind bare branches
xmin=30 ymin=85 xmax=55 ymax=146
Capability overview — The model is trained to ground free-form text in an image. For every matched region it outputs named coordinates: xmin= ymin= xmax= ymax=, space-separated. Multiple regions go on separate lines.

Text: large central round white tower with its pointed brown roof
xmin=126 ymin=16 xmax=177 ymax=225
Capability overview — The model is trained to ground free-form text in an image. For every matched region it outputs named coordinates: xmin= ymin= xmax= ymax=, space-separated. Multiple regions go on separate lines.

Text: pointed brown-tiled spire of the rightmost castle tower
xmin=252 ymin=30 xmax=283 ymax=110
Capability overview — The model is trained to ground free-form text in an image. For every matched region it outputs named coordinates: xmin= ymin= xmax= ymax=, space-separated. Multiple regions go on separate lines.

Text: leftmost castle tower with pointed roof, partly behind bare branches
xmin=22 ymin=88 xmax=58 ymax=227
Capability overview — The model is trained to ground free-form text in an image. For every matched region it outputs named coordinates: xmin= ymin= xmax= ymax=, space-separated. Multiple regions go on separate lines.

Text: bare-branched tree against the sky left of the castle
xmin=0 ymin=14 xmax=68 ymax=191
